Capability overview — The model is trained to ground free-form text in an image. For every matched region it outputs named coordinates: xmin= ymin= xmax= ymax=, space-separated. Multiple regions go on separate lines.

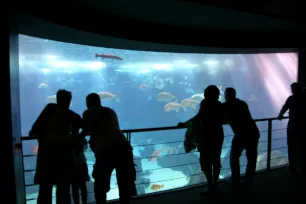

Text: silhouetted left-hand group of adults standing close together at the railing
xmin=30 ymin=90 xmax=136 ymax=204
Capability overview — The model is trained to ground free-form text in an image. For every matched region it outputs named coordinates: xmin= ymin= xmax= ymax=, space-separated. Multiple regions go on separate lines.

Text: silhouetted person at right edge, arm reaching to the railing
xmin=278 ymin=83 xmax=306 ymax=173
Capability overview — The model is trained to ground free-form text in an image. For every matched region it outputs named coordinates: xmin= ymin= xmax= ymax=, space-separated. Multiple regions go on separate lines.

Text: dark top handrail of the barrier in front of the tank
xmin=21 ymin=117 xmax=289 ymax=140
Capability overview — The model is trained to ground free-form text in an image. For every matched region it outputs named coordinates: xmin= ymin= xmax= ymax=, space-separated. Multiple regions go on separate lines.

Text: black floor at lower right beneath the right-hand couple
xmin=123 ymin=167 xmax=306 ymax=204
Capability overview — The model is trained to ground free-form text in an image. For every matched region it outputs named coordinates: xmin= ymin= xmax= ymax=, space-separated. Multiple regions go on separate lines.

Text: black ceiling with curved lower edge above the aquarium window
xmin=8 ymin=0 xmax=305 ymax=47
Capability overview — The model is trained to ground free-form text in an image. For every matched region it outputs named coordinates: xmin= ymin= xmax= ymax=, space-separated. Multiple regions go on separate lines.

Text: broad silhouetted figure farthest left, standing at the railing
xmin=30 ymin=90 xmax=82 ymax=204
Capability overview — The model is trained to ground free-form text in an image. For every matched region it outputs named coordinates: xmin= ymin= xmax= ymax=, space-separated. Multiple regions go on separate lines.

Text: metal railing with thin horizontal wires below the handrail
xmin=22 ymin=118 xmax=288 ymax=203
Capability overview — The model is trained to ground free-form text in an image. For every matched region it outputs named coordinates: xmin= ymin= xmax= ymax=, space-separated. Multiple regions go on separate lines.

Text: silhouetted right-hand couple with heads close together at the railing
xmin=179 ymin=85 xmax=259 ymax=194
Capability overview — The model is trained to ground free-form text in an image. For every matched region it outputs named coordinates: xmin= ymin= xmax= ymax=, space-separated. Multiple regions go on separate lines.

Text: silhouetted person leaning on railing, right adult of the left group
xmin=83 ymin=93 xmax=136 ymax=204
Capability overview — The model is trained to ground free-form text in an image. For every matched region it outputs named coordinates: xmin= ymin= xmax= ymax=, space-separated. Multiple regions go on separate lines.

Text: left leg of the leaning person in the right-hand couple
xmin=230 ymin=138 xmax=243 ymax=186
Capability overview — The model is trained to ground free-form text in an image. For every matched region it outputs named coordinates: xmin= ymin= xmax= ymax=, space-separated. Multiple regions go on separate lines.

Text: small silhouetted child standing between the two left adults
xmin=72 ymin=137 xmax=89 ymax=204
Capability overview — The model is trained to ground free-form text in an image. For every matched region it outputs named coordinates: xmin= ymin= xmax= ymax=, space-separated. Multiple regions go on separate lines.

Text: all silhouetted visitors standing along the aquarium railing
xmin=29 ymin=83 xmax=306 ymax=204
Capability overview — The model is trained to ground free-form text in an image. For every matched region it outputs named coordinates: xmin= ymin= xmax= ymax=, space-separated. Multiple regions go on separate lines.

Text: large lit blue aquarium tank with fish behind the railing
xmin=19 ymin=35 xmax=298 ymax=203
